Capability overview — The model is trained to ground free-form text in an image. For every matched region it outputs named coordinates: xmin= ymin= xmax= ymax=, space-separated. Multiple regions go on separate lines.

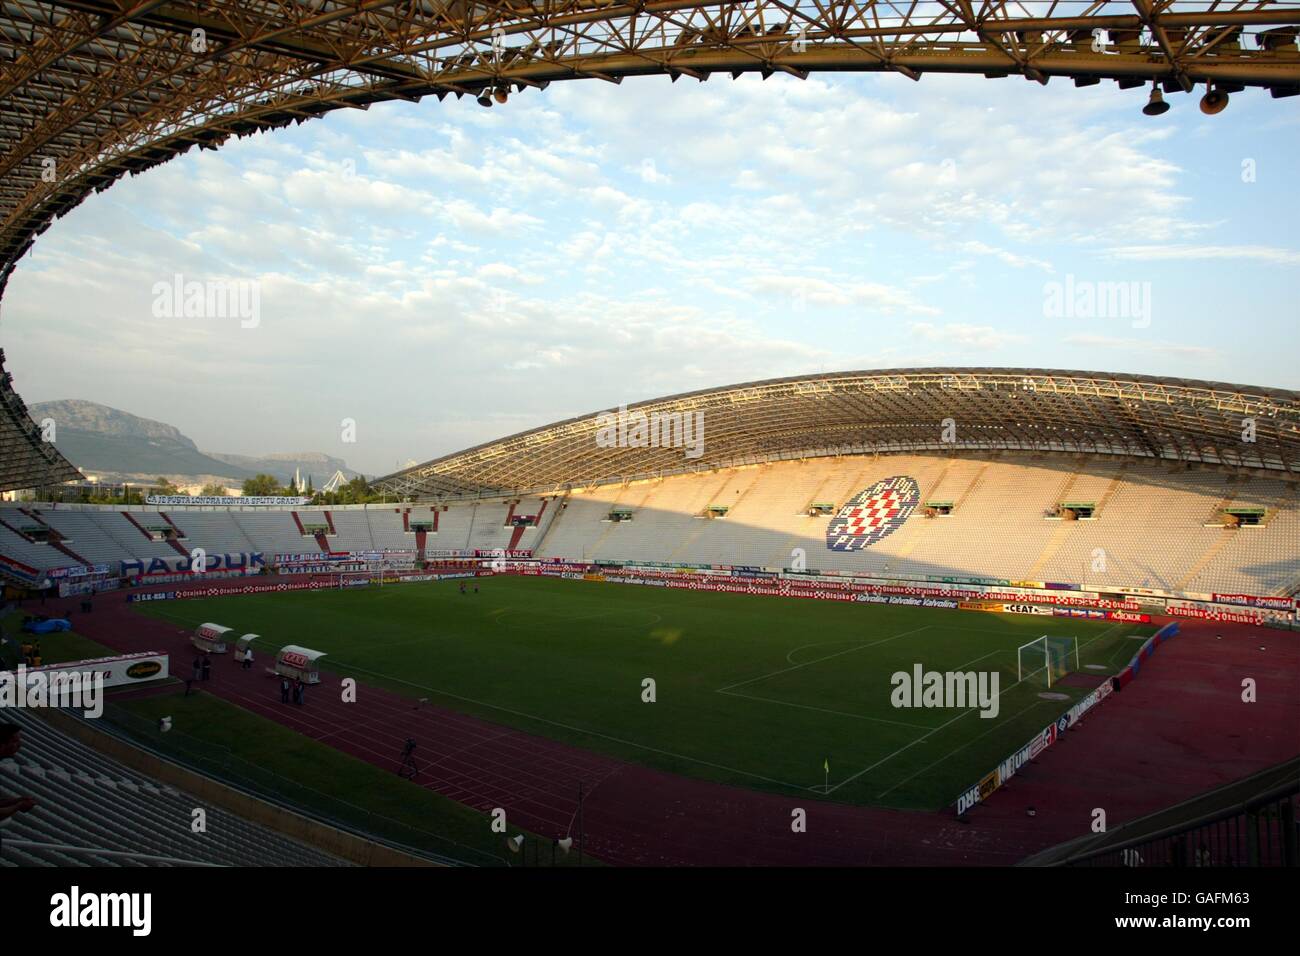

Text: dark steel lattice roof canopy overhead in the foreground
xmin=0 ymin=0 xmax=1300 ymax=280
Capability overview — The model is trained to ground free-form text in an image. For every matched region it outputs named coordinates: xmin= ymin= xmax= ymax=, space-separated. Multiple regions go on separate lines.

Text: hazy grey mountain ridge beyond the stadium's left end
xmin=27 ymin=399 xmax=358 ymax=488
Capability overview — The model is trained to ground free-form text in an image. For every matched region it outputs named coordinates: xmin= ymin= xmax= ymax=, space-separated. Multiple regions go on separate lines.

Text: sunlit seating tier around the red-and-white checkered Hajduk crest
xmin=527 ymin=454 xmax=1300 ymax=594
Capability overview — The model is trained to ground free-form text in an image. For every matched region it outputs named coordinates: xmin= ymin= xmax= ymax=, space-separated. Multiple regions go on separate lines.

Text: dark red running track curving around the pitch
xmin=29 ymin=581 xmax=1300 ymax=865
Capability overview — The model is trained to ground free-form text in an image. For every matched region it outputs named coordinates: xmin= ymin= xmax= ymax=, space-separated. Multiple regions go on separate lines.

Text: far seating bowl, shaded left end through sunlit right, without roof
xmin=0 ymin=453 xmax=1300 ymax=594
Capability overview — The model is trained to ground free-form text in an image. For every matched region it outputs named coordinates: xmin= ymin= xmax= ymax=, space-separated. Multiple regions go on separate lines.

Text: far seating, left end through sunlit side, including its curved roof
xmin=0 ymin=369 xmax=1300 ymax=596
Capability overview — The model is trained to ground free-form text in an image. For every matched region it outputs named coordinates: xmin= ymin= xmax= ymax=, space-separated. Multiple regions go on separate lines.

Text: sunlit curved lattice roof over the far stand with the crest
xmin=377 ymin=368 xmax=1300 ymax=498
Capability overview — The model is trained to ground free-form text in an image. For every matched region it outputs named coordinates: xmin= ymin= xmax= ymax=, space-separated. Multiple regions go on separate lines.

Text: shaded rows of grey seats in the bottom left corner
xmin=0 ymin=710 xmax=346 ymax=866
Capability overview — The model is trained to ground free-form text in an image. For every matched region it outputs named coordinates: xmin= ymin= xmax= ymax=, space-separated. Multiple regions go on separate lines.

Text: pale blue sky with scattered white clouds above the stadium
xmin=0 ymin=74 xmax=1300 ymax=475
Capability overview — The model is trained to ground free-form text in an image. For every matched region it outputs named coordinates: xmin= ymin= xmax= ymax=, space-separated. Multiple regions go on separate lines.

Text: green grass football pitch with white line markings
xmin=140 ymin=576 xmax=1153 ymax=809
